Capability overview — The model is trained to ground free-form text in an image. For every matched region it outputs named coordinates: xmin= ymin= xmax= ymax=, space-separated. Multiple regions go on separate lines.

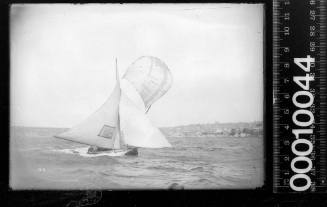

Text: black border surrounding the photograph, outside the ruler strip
xmin=0 ymin=0 xmax=327 ymax=207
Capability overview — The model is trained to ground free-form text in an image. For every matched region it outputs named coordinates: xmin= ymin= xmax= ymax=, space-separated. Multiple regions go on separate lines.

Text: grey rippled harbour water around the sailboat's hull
xmin=10 ymin=127 xmax=264 ymax=189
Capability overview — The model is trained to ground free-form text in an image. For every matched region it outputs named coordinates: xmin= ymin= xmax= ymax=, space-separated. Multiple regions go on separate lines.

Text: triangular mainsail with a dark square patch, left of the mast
xmin=55 ymin=84 xmax=120 ymax=148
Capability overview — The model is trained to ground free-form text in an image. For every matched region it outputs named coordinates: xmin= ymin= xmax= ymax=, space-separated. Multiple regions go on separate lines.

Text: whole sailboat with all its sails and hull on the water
xmin=55 ymin=56 xmax=172 ymax=156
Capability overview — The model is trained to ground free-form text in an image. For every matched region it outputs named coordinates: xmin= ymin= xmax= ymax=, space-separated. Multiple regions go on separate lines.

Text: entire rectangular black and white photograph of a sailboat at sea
xmin=9 ymin=3 xmax=265 ymax=190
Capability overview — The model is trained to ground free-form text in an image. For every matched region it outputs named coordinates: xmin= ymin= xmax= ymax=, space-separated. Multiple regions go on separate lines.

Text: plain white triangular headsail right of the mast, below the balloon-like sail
xmin=119 ymin=80 xmax=171 ymax=148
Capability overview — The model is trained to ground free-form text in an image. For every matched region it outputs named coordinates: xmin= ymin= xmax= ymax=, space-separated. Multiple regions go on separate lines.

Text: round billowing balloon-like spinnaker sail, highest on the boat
xmin=123 ymin=56 xmax=172 ymax=110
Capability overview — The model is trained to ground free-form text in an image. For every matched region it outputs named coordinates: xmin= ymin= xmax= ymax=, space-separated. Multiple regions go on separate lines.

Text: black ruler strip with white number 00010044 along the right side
xmin=272 ymin=0 xmax=327 ymax=193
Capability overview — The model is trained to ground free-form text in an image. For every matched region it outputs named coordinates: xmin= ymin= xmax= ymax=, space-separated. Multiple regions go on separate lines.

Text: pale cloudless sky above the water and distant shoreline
xmin=10 ymin=4 xmax=264 ymax=127
